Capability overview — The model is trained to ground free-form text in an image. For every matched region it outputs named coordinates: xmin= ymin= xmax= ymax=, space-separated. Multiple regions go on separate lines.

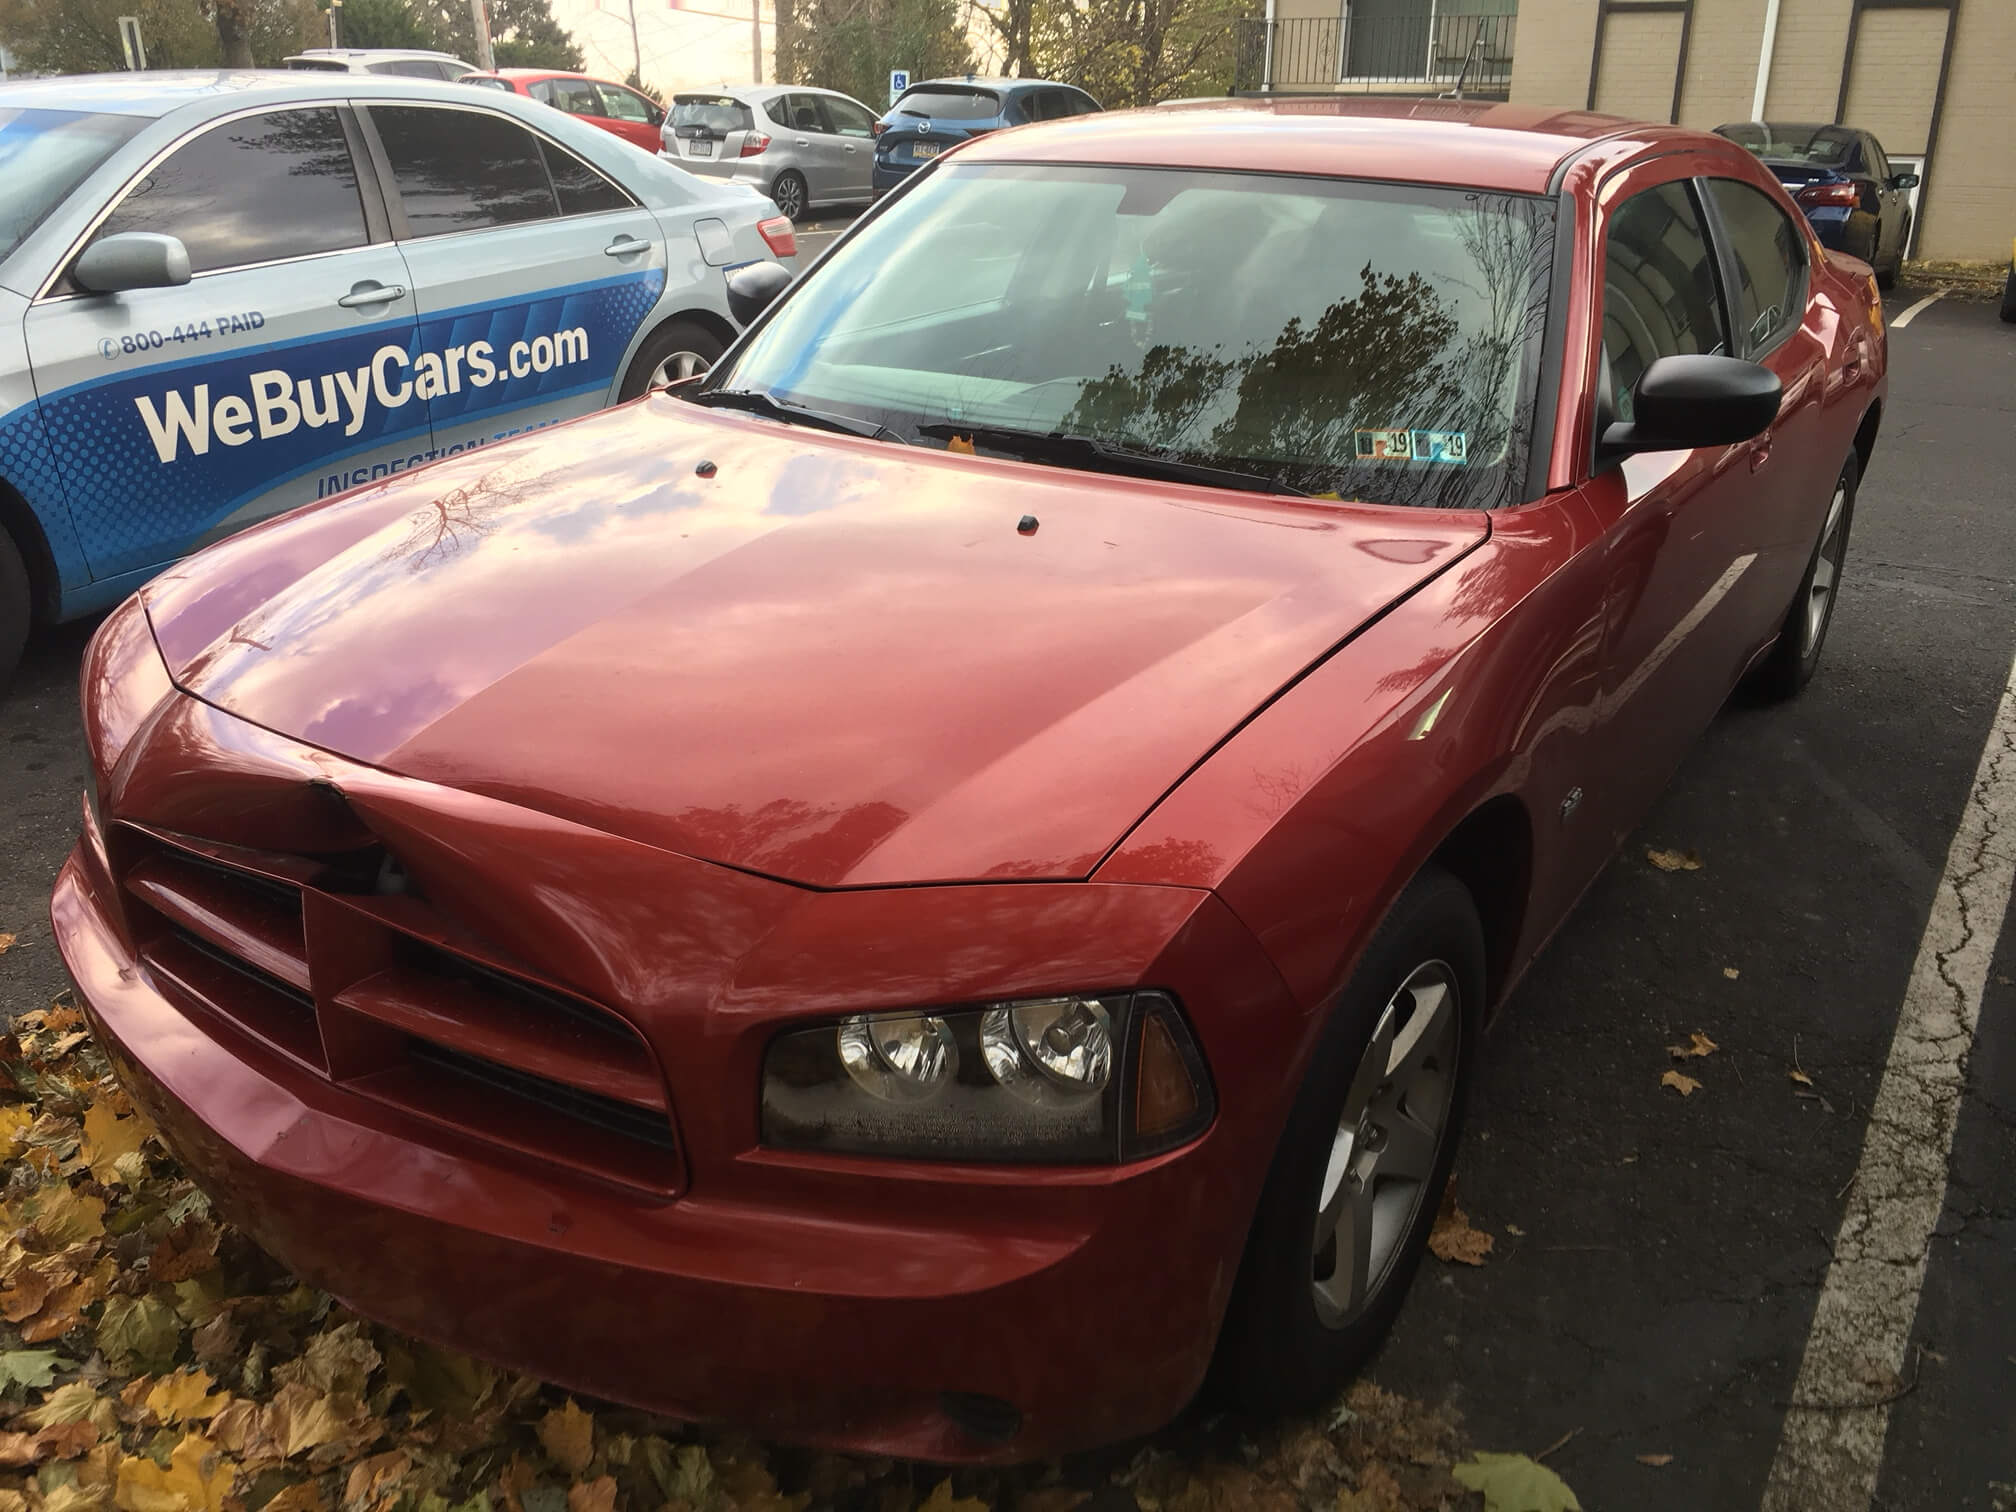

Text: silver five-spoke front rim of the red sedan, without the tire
xmin=1310 ymin=962 xmax=1462 ymax=1329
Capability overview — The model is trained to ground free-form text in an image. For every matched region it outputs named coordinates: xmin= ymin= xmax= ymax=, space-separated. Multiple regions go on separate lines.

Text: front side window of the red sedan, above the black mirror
xmin=1603 ymin=183 xmax=1724 ymax=419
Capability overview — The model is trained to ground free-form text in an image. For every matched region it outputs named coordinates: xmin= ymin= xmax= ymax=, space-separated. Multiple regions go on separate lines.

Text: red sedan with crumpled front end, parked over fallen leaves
xmin=54 ymin=101 xmax=1885 ymax=1462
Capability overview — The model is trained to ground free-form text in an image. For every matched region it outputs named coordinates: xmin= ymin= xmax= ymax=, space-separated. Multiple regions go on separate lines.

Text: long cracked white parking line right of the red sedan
xmin=1764 ymin=653 xmax=2016 ymax=1512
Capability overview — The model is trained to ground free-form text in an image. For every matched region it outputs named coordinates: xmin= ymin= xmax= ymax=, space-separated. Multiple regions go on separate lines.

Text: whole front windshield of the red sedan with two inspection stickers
xmin=700 ymin=161 xmax=1554 ymax=508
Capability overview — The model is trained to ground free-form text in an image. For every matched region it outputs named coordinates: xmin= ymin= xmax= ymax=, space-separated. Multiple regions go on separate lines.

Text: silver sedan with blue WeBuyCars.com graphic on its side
xmin=0 ymin=73 xmax=794 ymax=681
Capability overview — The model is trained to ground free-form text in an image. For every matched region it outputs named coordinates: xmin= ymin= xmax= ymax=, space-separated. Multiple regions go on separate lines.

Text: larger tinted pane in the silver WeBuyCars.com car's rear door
xmin=371 ymin=105 xmax=556 ymax=236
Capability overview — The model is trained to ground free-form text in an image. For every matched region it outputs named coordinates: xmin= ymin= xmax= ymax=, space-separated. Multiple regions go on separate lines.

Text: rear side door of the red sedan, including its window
xmin=1699 ymin=177 xmax=1845 ymax=620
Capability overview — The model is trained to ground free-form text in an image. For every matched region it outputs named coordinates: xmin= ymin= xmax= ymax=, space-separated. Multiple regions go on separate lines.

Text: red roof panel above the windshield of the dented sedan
xmin=960 ymin=97 xmax=1701 ymax=194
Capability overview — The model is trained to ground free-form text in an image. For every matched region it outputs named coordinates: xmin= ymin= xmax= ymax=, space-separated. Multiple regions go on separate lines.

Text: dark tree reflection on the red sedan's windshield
xmin=1062 ymin=206 xmax=1550 ymax=508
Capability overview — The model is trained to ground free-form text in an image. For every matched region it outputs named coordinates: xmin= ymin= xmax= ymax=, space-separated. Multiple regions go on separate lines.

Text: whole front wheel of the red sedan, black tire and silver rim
xmin=1214 ymin=867 xmax=1484 ymax=1415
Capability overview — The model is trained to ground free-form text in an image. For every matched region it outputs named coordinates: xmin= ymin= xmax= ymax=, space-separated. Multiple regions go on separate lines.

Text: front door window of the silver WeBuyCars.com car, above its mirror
xmin=99 ymin=109 xmax=367 ymax=272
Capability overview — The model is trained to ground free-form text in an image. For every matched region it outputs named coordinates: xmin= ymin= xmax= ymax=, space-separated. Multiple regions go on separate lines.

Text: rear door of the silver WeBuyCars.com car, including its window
xmin=361 ymin=103 xmax=665 ymax=454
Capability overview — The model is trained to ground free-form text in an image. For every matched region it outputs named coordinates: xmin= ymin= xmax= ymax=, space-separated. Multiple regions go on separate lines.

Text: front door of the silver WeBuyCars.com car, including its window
xmin=26 ymin=105 xmax=429 ymax=579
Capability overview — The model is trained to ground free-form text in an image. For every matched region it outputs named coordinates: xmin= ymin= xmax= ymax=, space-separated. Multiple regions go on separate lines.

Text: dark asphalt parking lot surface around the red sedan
xmin=0 ymin=282 xmax=2016 ymax=1510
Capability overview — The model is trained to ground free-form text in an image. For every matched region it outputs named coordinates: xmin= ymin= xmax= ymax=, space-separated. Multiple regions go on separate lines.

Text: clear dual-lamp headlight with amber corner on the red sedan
xmin=762 ymin=992 xmax=1212 ymax=1163
